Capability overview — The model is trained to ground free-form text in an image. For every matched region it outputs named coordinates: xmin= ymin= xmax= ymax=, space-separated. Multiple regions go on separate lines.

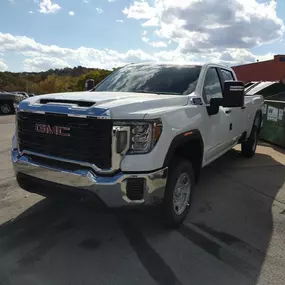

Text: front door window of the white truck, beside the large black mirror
xmin=203 ymin=67 xmax=223 ymax=104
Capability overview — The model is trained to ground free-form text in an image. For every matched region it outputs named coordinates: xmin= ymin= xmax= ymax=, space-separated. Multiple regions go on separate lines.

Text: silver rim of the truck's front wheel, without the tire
xmin=173 ymin=173 xmax=191 ymax=215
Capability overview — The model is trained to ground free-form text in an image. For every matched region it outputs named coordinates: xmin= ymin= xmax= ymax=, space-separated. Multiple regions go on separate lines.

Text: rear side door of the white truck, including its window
xmin=218 ymin=68 xmax=246 ymax=141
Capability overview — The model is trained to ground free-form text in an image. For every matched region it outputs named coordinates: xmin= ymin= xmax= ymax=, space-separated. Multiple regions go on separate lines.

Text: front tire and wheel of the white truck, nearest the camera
xmin=163 ymin=158 xmax=195 ymax=228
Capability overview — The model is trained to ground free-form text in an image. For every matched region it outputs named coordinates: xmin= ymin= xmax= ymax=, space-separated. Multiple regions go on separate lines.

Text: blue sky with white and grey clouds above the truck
xmin=0 ymin=0 xmax=285 ymax=72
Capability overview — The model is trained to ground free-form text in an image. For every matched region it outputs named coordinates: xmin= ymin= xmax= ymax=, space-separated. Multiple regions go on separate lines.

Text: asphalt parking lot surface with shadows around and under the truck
xmin=0 ymin=116 xmax=285 ymax=285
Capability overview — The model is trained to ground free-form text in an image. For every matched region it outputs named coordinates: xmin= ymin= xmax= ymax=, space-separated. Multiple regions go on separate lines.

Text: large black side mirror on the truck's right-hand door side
xmin=223 ymin=81 xmax=244 ymax=108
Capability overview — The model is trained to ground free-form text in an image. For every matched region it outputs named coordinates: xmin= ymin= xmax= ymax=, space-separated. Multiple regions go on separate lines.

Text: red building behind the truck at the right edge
xmin=232 ymin=55 xmax=285 ymax=83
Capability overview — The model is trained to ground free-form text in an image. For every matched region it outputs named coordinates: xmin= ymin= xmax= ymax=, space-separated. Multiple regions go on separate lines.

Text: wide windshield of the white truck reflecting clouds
xmin=92 ymin=64 xmax=201 ymax=95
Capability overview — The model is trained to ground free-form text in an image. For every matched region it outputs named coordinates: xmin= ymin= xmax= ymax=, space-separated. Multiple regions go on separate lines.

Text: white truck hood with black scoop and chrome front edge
xmin=19 ymin=91 xmax=188 ymax=119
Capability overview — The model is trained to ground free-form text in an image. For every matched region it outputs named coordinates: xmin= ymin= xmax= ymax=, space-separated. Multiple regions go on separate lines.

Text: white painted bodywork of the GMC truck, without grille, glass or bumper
xmin=18 ymin=64 xmax=263 ymax=172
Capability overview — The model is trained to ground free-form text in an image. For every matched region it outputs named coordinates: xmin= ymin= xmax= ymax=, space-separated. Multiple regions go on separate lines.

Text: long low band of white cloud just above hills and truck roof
xmin=0 ymin=31 xmax=273 ymax=71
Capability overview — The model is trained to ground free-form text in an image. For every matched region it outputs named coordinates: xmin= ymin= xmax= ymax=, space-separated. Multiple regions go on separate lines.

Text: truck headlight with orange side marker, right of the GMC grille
xmin=115 ymin=120 xmax=162 ymax=154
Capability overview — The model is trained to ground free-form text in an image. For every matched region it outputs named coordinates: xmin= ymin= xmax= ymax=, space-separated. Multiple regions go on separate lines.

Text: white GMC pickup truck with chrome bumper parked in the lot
xmin=12 ymin=63 xmax=263 ymax=227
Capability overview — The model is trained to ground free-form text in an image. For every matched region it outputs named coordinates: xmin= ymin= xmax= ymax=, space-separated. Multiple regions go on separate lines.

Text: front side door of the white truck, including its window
xmin=202 ymin=67 xmax=231 ymax=163
